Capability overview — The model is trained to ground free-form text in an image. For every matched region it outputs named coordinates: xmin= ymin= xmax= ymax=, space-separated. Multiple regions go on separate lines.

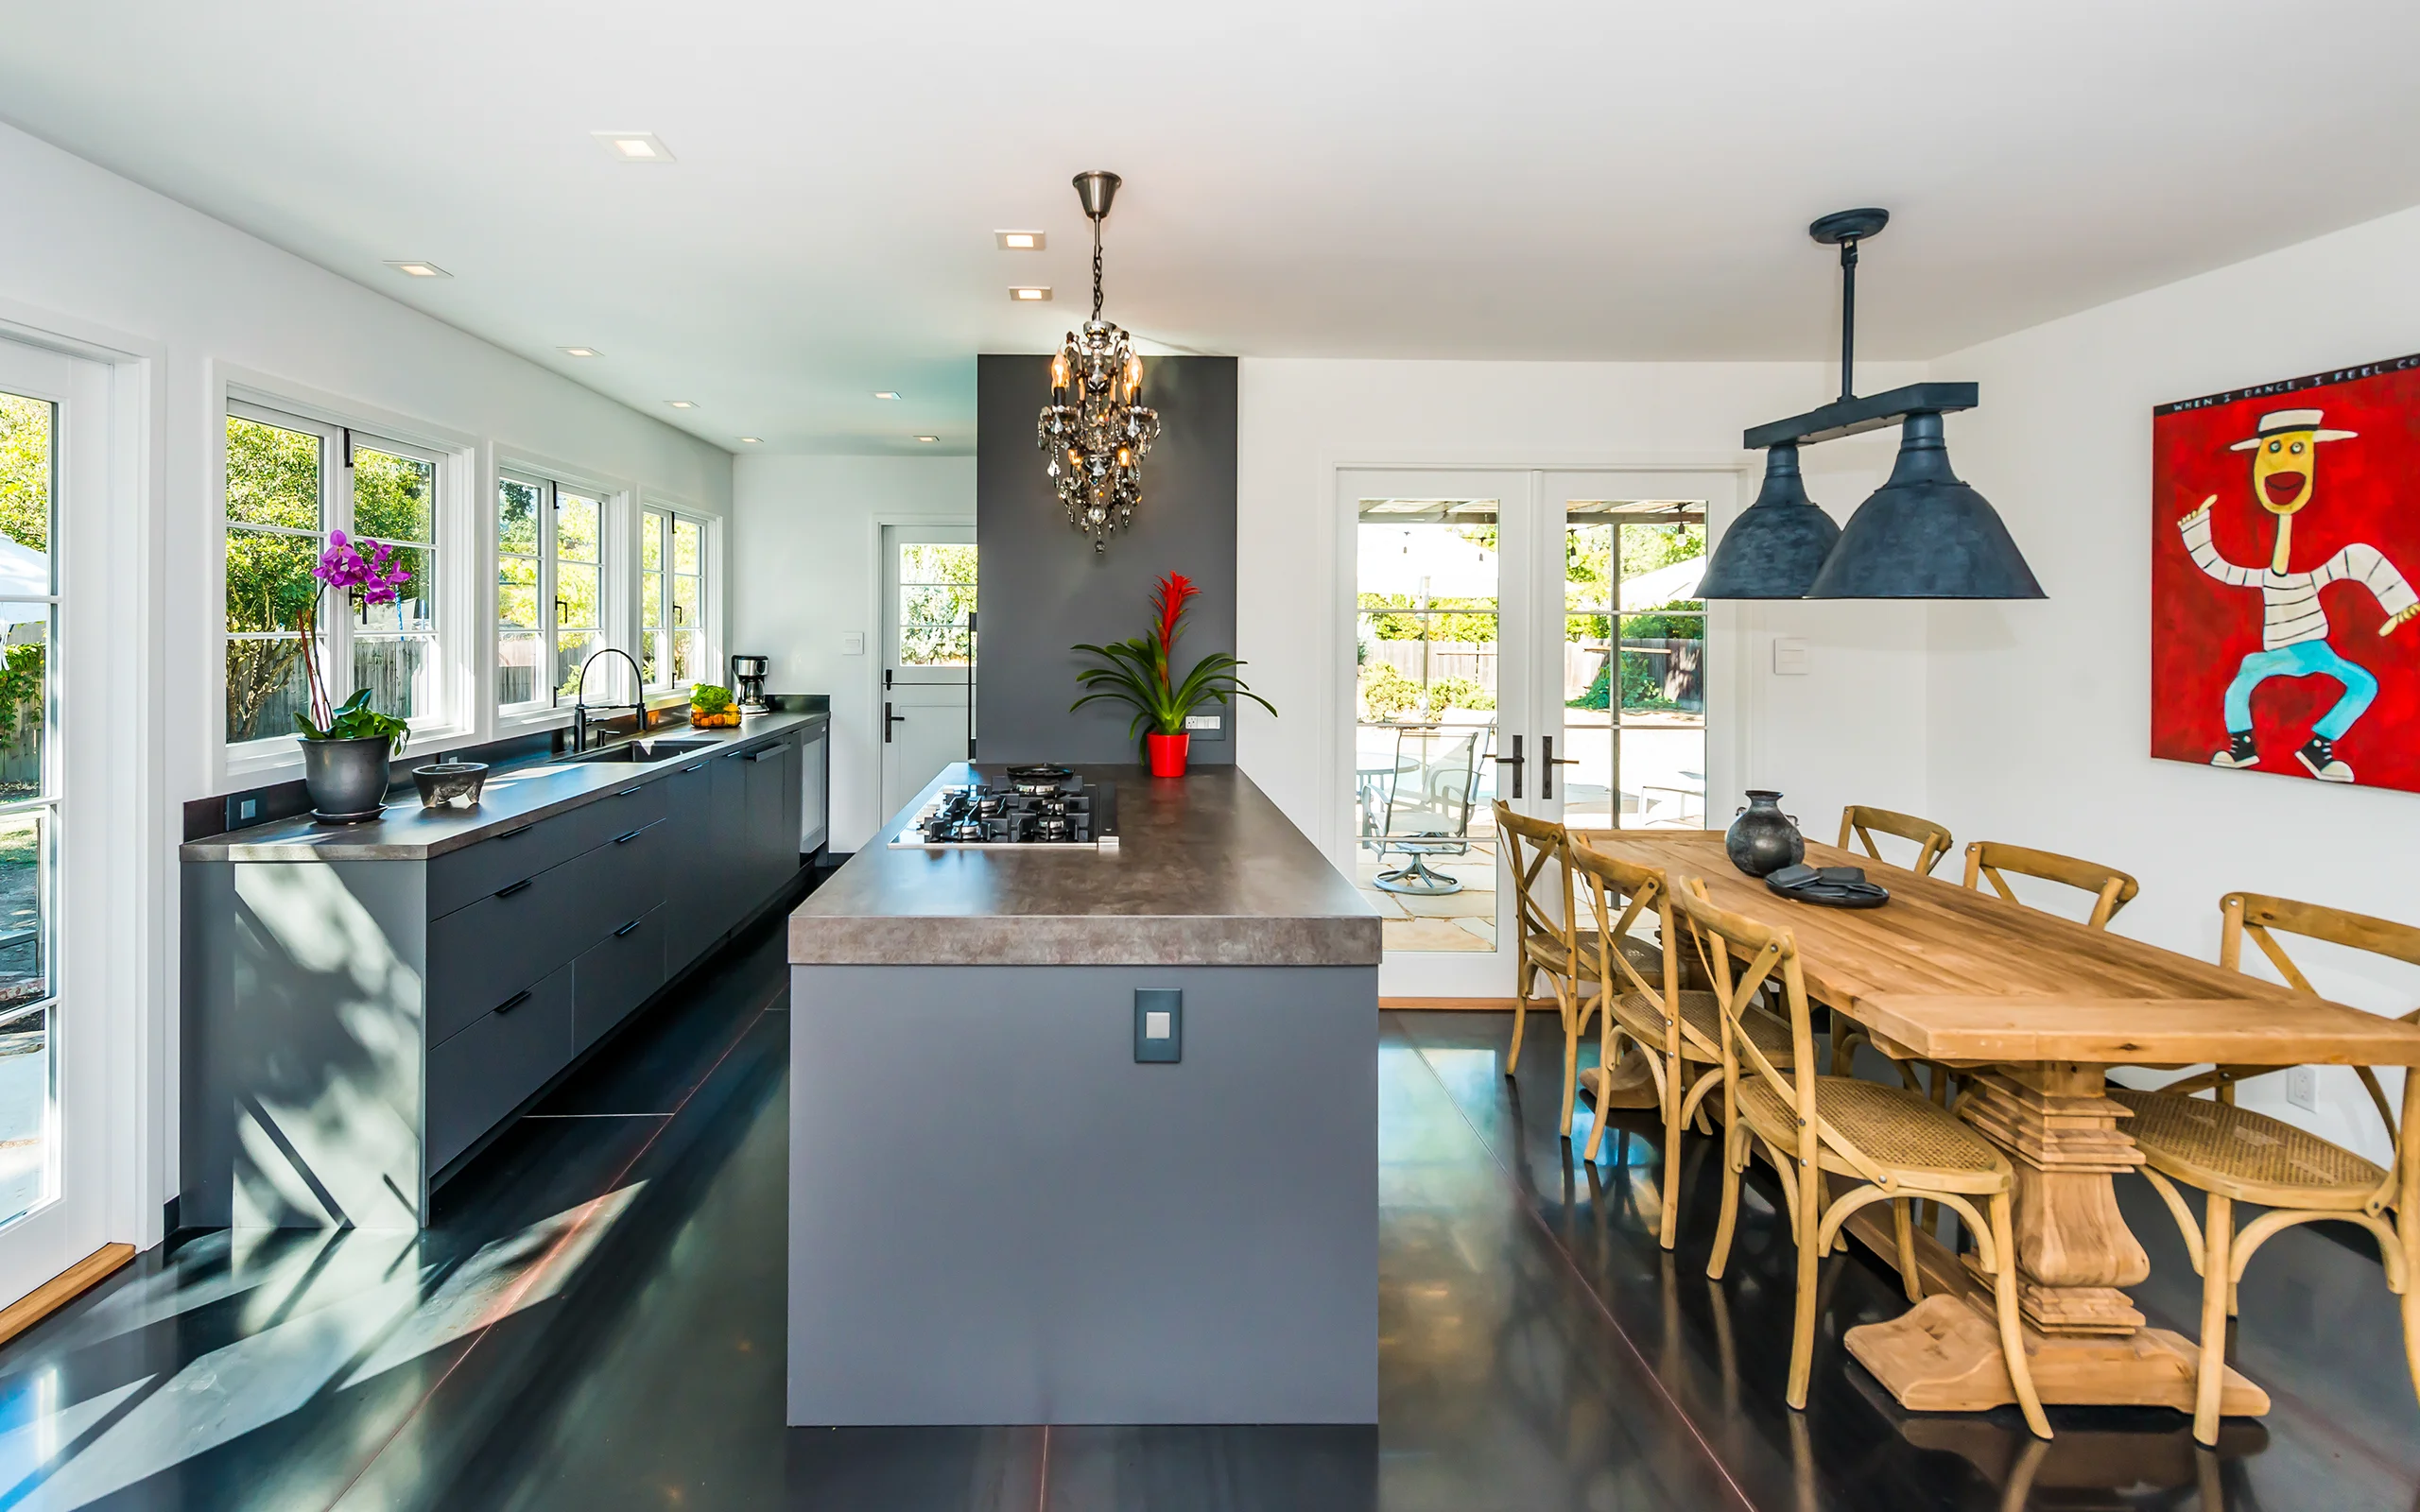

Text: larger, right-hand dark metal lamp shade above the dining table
xmin=1800 ymin=411 xmax=2048 ymax=597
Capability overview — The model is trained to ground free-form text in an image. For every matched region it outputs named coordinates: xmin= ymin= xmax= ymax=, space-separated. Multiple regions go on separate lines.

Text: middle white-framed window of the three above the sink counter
xmin=496 ymin=470 xmax=610 ymax=713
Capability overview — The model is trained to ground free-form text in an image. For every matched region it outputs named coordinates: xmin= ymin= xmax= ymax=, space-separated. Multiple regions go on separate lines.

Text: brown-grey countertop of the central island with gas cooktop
xmin=789 ymin=762 xmax=1379 ymax=965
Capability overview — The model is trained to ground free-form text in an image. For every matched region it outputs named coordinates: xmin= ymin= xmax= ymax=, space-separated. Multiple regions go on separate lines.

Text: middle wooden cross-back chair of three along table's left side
xmin=1570 ymin=844 xmax=1790 ymax=1248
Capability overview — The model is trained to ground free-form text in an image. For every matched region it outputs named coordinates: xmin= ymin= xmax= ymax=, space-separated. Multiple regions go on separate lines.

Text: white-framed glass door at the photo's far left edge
xmin=0 ymin=341 xmax=113 ymax=1301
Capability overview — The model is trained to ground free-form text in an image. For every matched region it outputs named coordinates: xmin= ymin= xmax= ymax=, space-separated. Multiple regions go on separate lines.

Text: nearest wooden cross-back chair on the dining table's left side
xmin=1672 ymin=878 xmax=2049 ymax=1439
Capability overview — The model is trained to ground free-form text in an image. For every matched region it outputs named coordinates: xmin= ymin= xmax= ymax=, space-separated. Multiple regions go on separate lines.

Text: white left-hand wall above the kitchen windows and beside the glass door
xmin=0 ymin=126 xmax=731 ymax=1241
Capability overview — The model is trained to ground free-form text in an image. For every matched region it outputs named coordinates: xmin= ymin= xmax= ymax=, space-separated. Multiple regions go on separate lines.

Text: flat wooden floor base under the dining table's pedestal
xmin=1846 ymin=1295 xmax=2270 ymax=1418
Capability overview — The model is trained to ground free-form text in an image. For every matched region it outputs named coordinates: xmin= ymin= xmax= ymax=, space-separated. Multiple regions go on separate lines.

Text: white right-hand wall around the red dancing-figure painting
xmin=1927 ymin=211 xmax=2420 ymax=1154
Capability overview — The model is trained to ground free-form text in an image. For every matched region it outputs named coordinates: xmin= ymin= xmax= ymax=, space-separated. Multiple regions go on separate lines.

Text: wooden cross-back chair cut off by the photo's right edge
xmin=2110 ymin=893 xmax=2420 ymax=1444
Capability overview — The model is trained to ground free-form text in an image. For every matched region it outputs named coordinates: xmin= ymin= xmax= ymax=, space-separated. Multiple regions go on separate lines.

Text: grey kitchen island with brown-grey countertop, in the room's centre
xmin=789 ymin=765 xmax=1379 ymax=1425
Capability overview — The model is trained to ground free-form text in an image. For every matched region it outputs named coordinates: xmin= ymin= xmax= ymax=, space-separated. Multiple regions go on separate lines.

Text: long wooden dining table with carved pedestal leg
xmin=1573 ymin=830 xmax=2420 ymax=1416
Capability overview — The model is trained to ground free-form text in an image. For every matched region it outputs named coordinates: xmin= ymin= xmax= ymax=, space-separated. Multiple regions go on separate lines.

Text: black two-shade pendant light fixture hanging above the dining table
xmin=1699 ymin=208 xmax=2045 ymax=597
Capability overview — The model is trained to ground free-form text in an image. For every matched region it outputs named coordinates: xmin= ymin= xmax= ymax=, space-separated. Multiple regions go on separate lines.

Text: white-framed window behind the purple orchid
xmin=223 ymin=399 xmax=450 ymax=755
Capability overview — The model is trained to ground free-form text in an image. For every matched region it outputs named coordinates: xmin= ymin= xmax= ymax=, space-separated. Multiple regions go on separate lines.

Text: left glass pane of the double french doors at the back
xmin=1353 ymin=498 xmax=1500 ymax=954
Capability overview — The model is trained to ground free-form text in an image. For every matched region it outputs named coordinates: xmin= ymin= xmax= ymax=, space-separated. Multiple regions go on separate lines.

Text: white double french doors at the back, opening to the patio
xmin=1339 ymin=470 xmax=1737 ymax=999
